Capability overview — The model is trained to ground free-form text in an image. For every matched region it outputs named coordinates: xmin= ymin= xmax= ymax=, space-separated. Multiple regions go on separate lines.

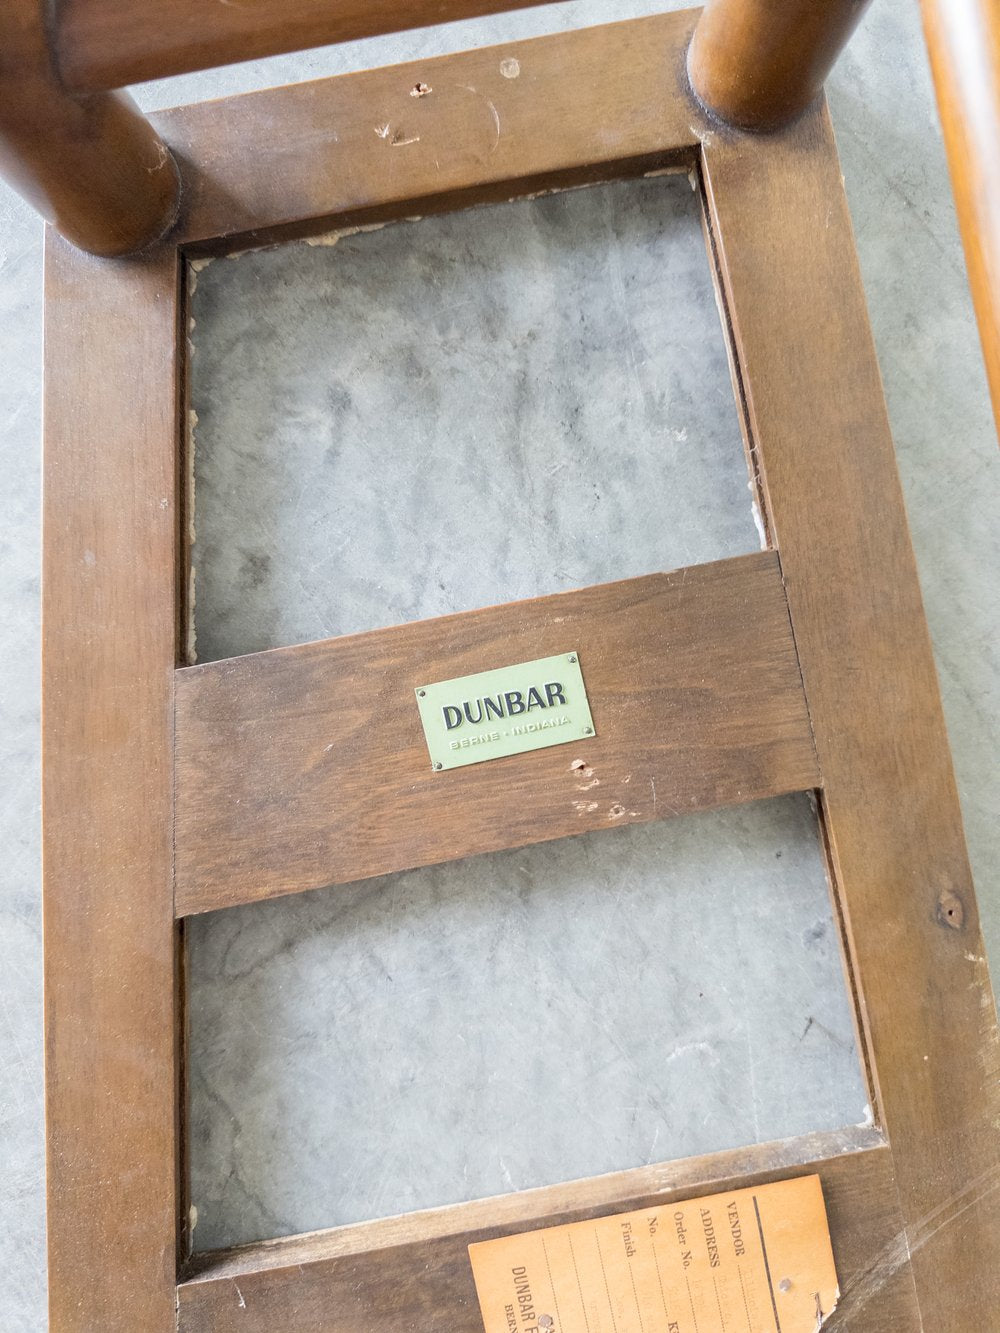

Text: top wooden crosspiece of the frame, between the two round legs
xmin=152 ymin=11 xmax=707 ymax=251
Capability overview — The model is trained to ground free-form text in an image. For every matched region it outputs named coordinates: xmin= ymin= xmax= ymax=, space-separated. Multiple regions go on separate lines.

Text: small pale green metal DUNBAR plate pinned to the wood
xmin=416 ymin=653 xmax=593 ymax=769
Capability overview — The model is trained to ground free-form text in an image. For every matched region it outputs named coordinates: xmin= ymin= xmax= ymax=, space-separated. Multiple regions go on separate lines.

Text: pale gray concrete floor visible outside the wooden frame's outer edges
xmin=0 ymin=0 xmax=1000 ymax=1333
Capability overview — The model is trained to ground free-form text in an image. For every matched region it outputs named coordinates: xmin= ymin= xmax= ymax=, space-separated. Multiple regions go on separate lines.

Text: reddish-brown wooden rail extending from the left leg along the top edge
xmin=55 ymin=0 xmax=568 ymax=92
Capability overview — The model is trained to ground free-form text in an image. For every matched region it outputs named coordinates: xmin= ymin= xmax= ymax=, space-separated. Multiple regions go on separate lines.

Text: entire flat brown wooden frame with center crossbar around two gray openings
xmin=44 ymin=12 xmax=1000 ymax=1333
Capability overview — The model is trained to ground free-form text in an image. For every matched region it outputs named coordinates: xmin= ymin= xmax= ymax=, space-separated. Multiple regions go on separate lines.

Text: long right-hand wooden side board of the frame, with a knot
xmin=704 ymin=107 xmax=1000 ymax=1330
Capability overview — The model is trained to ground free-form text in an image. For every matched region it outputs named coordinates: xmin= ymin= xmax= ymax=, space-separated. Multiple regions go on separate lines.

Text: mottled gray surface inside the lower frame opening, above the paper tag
xmin=191 ymin=797 xmax=867 ymax=1249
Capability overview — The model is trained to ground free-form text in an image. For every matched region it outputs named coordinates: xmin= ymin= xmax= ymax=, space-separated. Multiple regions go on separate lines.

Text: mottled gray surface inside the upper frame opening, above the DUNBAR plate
xmin=192 ymin=175 xmax=759 ymax=665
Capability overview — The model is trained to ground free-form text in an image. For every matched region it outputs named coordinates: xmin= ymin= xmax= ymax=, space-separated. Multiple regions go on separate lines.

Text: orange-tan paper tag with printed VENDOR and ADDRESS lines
xmin=469 ymin=1176 xmax=840 ymax=1333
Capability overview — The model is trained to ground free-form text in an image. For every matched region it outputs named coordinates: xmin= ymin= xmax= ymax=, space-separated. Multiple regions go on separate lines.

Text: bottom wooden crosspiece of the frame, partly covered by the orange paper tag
xmin=177 ymin=1130 xmax=920 ymax=1333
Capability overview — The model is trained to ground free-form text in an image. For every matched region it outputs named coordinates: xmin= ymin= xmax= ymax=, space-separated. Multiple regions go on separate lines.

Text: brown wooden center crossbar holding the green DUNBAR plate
xmin=176 ymin=552 xmax=819 ymax=916
